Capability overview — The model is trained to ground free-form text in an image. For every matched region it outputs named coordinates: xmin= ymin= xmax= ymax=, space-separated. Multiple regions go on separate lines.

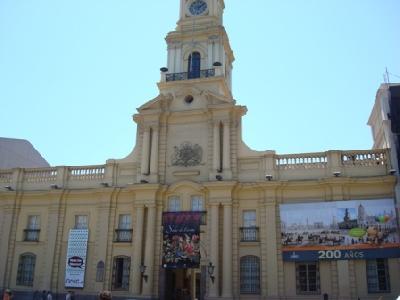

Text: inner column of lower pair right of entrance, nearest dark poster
xmin=208 ymin=203 xmax=219 ymax=297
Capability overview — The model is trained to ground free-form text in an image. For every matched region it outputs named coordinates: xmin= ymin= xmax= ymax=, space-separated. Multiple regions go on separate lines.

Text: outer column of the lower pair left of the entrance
xmin=132 ymin=206 xmax=144 ymax=295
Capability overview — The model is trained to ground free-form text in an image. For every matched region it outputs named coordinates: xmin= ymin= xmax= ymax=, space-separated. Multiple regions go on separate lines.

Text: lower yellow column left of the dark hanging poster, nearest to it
xmin=142 ymin=205 xmax=156 ymax=296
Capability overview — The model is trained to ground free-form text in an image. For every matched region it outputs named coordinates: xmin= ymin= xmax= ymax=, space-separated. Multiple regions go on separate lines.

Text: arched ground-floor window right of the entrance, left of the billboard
xmin=240 ymin=255 xmax=260 ymax=294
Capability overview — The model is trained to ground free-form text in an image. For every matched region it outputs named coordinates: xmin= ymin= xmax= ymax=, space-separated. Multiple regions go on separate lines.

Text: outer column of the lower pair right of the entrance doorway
xmin=222 ymin=204 xmax=232 ymax=298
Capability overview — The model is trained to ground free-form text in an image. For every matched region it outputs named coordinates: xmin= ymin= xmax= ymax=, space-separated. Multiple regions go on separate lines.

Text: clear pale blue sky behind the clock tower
xmin=0 ymin=0 xmax=400 ymax=166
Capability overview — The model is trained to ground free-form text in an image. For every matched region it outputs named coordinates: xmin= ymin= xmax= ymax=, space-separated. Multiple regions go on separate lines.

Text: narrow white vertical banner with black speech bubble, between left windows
xmin=64 ymin=229 xmax=89 ymax=288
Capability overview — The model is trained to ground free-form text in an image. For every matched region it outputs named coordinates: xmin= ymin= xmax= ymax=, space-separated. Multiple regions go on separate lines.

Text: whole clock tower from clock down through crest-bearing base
xmin=131 ymin=0 xmax=246 ymax=184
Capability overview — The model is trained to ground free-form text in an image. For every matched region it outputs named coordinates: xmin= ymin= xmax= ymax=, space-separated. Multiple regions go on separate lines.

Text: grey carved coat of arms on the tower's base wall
xmin=172 ymin=142 xmax=203 ymax=167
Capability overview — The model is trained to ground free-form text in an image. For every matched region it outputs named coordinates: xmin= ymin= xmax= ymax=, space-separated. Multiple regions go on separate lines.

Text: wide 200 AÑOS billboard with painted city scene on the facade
xmin=279 ymin=199 xmax=400 ymax=261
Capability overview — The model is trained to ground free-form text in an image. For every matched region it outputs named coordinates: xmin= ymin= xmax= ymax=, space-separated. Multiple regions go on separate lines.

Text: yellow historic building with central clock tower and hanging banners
xmin=0 ymin=0 xmax=400 ymax=300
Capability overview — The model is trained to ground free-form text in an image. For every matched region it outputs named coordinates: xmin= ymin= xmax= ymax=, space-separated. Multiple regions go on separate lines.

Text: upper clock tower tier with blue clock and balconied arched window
xmin=159 ymin=0 xmax=234 ymax=97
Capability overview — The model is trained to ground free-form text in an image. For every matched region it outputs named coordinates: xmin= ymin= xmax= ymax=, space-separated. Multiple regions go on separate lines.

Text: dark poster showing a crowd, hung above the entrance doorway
xmin=162 ymin=212 xmax=203 ymax=269
